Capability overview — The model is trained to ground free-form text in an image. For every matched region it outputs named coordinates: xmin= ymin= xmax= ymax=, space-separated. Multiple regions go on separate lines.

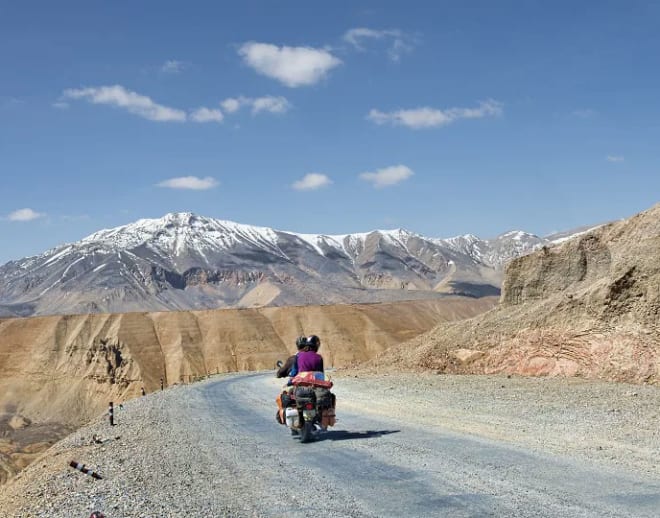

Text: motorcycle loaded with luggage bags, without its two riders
xmin=276 ymin=362 xmax=336 ymax=443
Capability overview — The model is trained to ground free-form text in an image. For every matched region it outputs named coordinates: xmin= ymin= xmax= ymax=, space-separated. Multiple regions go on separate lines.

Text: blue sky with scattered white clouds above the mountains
xmin=0 ymin=0 xmax=660 ymax=262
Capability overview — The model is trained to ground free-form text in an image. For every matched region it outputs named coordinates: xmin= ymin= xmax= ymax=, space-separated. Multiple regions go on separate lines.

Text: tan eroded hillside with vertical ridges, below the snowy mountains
xmin=0 ymin=297 xmax=496 ymax=481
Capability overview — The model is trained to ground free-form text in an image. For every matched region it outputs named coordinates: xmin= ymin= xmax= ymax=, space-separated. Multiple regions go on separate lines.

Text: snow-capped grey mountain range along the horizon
xmin=0 ymin=213 xmax=592 ymax=315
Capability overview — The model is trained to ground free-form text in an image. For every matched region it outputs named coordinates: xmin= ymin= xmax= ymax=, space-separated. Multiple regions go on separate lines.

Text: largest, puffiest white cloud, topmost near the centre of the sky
xmin=238 ymin=42 xmax=342 ymax=88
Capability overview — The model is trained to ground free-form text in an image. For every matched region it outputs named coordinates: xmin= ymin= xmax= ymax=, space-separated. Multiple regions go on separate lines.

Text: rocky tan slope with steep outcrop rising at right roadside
xmin=369 ymin=205 xmax=660 ymax=383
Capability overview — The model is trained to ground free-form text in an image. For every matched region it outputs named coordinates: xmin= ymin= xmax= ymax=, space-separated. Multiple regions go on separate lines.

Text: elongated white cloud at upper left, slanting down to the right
xmin=63 ymin=85 xmax=186 ymax=122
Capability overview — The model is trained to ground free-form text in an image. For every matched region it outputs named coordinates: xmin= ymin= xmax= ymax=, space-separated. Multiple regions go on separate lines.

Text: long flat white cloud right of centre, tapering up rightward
xmin=367 ymin=99 xmax=502 ymax=129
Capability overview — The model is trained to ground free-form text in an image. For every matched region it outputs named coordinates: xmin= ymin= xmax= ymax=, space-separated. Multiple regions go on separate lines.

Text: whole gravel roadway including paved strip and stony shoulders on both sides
xmin=0 ymin=373 xmax=660 ymax=518
